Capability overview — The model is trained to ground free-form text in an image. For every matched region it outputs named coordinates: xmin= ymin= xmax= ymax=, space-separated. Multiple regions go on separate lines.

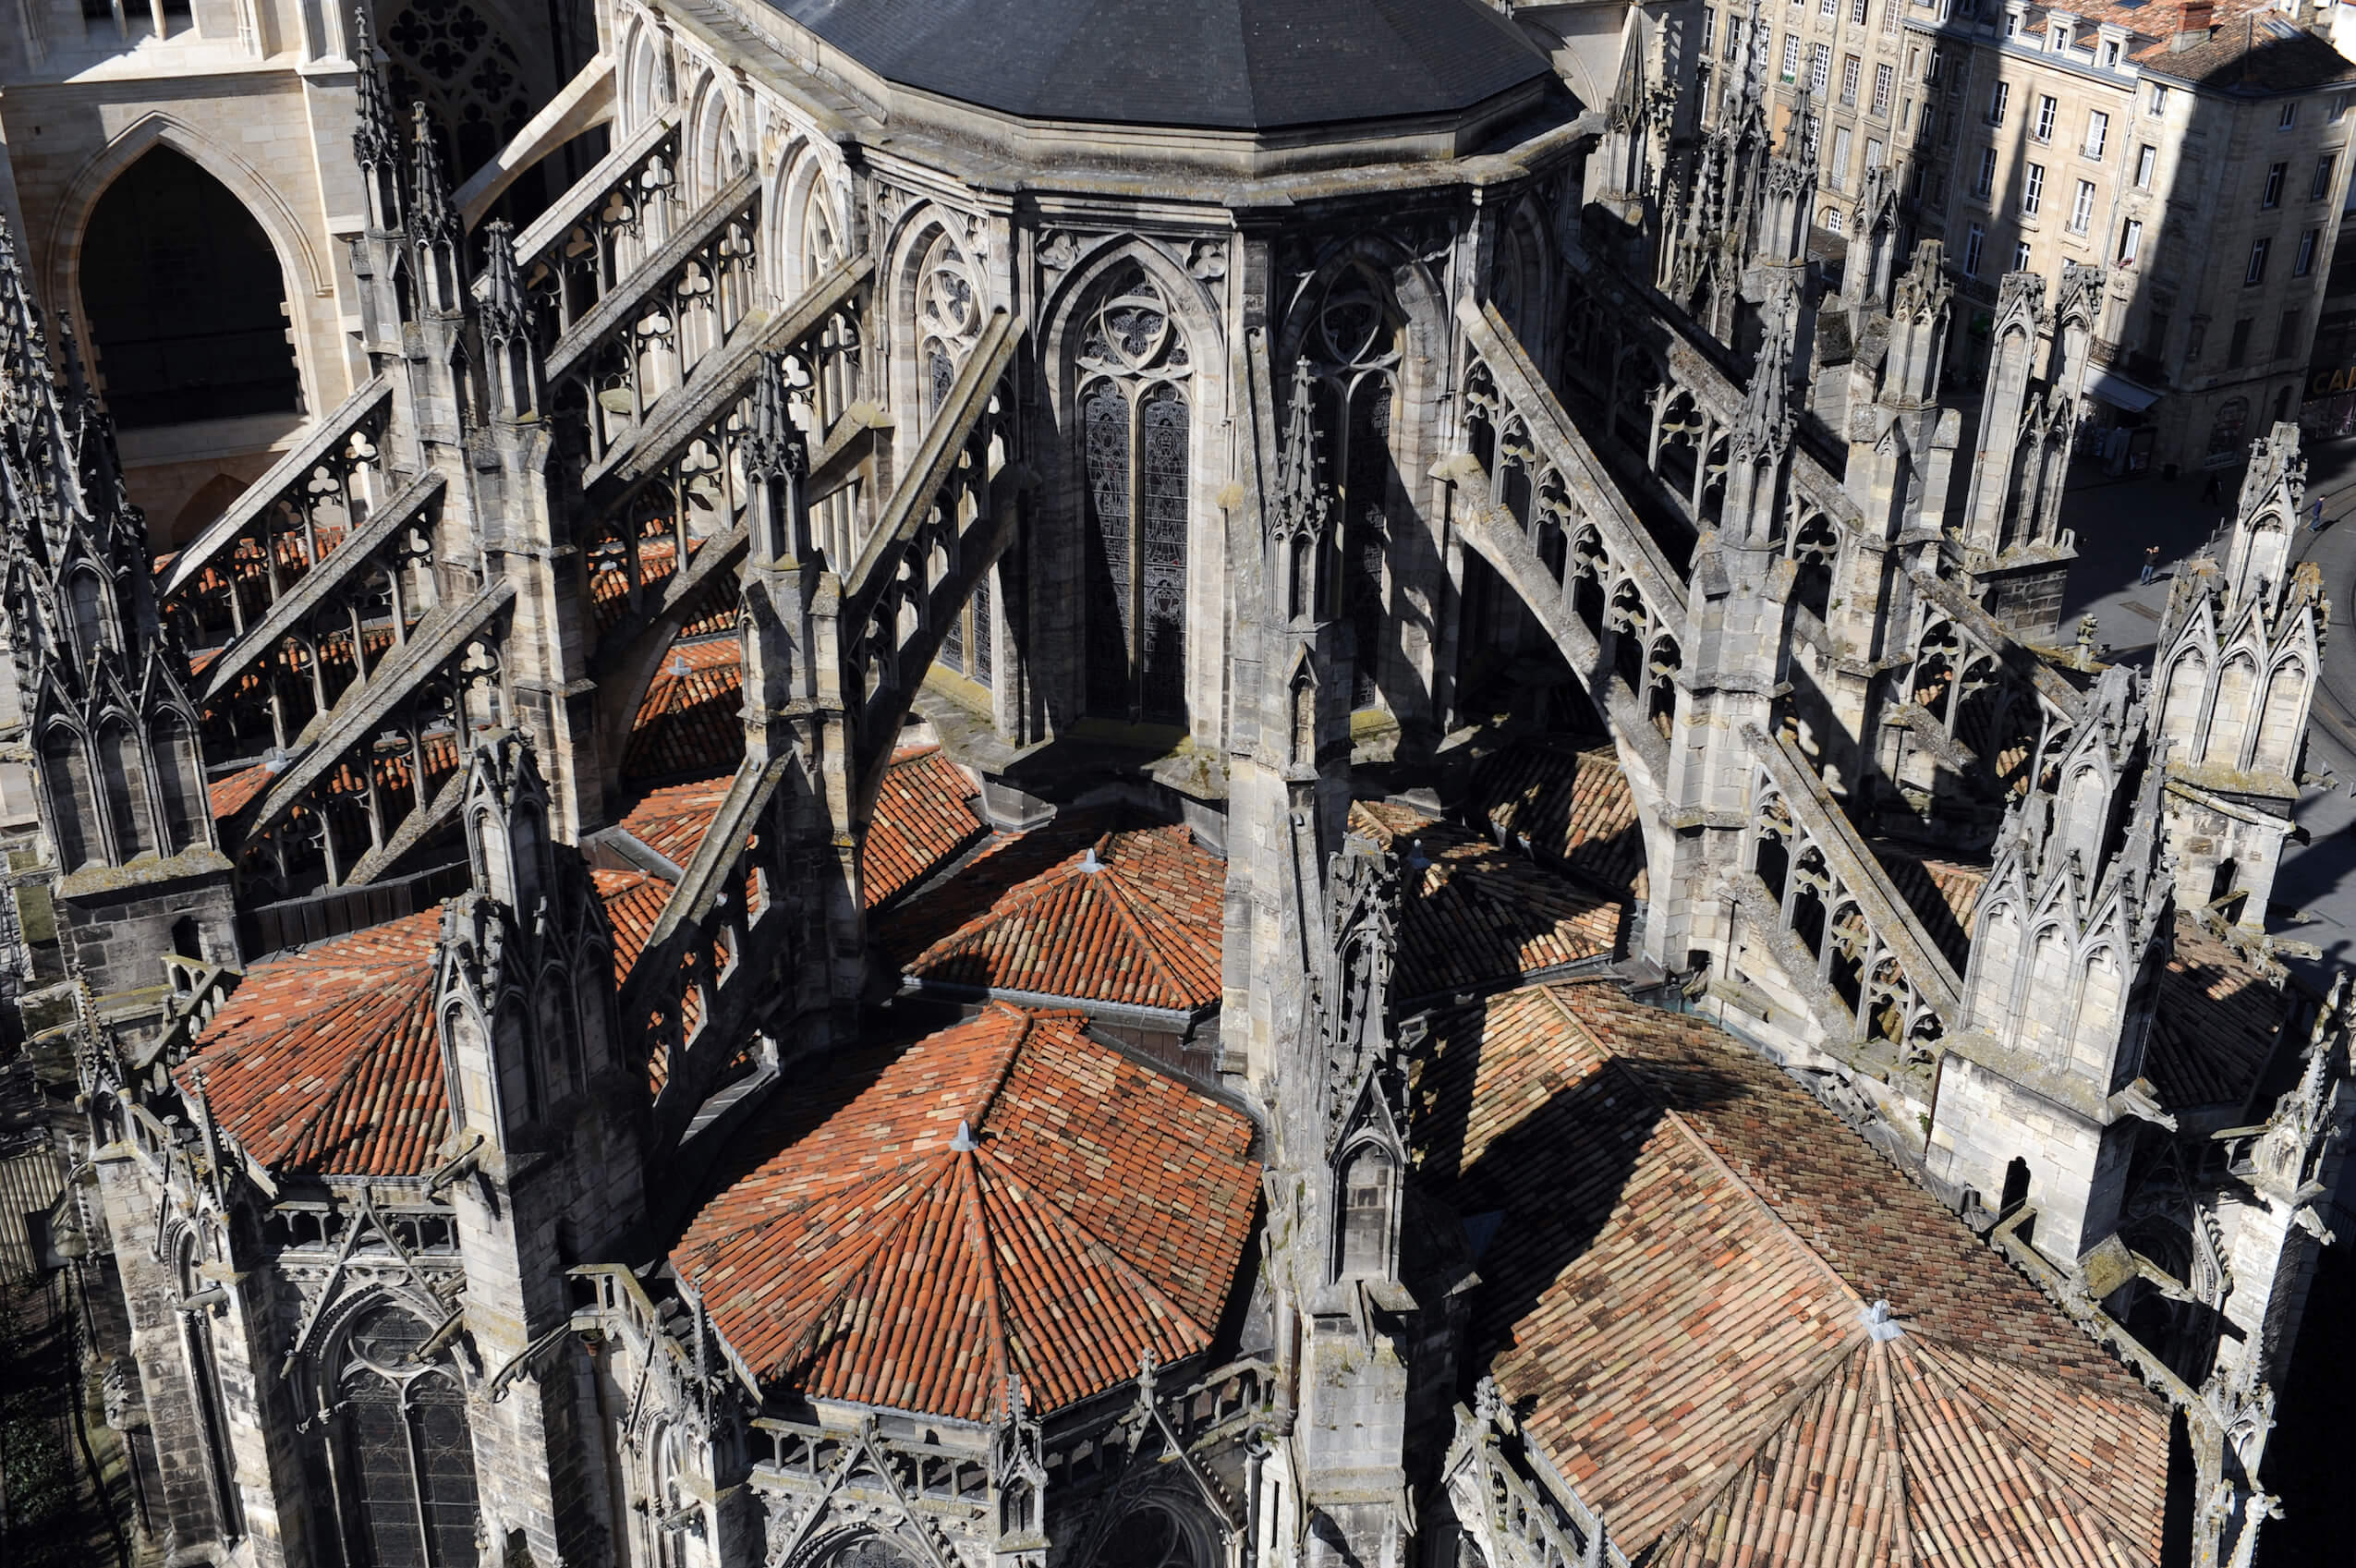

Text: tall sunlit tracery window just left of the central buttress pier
xmin=1079 ymin=264 xmax=1192 ymax=722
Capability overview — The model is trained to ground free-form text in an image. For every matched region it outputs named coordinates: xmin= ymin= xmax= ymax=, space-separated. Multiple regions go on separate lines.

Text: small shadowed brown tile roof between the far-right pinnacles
xmin=2144 ymin=915 xmax=2290 ymax=1111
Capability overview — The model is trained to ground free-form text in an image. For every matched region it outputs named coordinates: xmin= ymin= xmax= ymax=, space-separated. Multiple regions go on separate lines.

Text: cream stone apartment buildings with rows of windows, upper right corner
xmin=1706 ymin=0 xmax=2356 ymax=474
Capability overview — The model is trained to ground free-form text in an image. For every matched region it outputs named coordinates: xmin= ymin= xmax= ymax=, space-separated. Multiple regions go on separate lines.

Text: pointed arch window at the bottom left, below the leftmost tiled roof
xmin=330 ymin=1304 xmax=479 ymax=1568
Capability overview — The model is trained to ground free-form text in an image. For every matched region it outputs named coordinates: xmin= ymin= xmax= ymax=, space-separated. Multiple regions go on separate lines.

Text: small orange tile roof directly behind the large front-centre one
xmin=877 ymin=813 xmax=1228 ymax=1012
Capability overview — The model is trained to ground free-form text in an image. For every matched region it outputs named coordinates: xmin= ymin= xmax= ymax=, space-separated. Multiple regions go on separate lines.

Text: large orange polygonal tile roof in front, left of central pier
xmin=672 ymin=1003 xmax=1260 ymax=1419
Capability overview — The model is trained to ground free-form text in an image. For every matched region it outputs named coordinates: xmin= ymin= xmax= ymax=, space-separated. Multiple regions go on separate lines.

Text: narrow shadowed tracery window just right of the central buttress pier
xmin=1303 ymin=266 xmax=1406 ymax=708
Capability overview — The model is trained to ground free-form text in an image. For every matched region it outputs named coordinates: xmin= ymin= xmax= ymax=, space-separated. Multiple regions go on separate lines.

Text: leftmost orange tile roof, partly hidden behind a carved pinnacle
xmin=181 ymin=870 xmax=669 ymax=1176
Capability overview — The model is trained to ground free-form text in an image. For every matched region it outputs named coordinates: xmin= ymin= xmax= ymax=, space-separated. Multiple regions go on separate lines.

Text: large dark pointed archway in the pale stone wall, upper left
xmin=82 ymin=146 xmax=301 ymax=429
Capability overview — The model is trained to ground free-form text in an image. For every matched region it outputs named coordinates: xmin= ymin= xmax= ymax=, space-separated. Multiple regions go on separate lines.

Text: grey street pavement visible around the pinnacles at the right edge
xmin=2061 ymin=439 xmax=2356 ymax=983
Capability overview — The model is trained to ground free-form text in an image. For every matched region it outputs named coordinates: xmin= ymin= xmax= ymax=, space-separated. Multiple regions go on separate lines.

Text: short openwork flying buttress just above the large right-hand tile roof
xmin=1743 ymin=726 xmax=1962 ymax=1051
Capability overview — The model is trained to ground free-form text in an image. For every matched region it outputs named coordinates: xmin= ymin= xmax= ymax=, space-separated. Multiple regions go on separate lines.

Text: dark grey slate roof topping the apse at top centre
xmin=771 ymin=0 xmax=1548 ymax=129
